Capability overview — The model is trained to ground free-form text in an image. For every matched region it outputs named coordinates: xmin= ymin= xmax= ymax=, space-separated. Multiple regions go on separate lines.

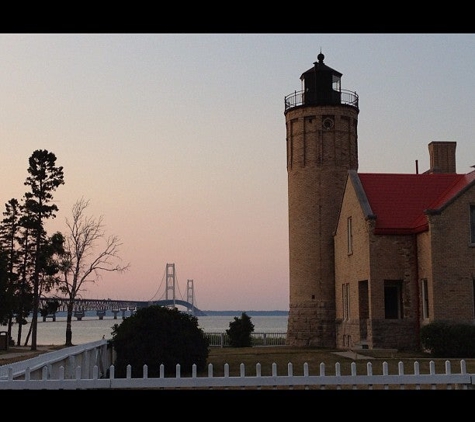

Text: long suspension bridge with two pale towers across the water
xmin=39 ymin=264 xmax=206 ymax=321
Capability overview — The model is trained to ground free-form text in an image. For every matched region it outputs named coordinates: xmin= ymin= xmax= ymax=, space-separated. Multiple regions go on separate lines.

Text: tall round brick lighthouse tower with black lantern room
xmin=285 ymin=53 xmax=359 ymax=348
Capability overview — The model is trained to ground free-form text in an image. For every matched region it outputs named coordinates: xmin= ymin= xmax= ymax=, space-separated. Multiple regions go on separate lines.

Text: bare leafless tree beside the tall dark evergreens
xmin=58 ymin=198 xmax=129 ymax=346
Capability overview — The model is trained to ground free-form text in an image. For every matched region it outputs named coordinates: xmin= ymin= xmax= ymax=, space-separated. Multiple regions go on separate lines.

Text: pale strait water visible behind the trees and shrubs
xmin=6 ymin=315 xmax=288 ymax=345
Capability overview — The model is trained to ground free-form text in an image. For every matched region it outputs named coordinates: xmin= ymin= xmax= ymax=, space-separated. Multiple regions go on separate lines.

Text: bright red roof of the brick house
xmin=358 ymin=171 xmax=475 ymax=234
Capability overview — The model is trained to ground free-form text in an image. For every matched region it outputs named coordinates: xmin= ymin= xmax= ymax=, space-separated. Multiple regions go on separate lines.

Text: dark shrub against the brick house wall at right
xmin=420 ymin=321 xmax=475 ymax=358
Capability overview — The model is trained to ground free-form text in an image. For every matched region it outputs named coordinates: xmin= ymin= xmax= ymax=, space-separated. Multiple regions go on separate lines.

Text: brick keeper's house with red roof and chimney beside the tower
xmin=334 ymin=142 xmax=475 ymax=350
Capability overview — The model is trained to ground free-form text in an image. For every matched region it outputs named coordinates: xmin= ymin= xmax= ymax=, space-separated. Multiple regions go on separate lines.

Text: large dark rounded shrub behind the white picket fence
xmin=111 ymin=305 xmax=209 ymax=377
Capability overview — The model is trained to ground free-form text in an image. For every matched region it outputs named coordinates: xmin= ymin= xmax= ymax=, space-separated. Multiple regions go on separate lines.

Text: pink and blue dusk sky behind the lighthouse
xmin=0 ymin=33 xmax=475 ymax=311
